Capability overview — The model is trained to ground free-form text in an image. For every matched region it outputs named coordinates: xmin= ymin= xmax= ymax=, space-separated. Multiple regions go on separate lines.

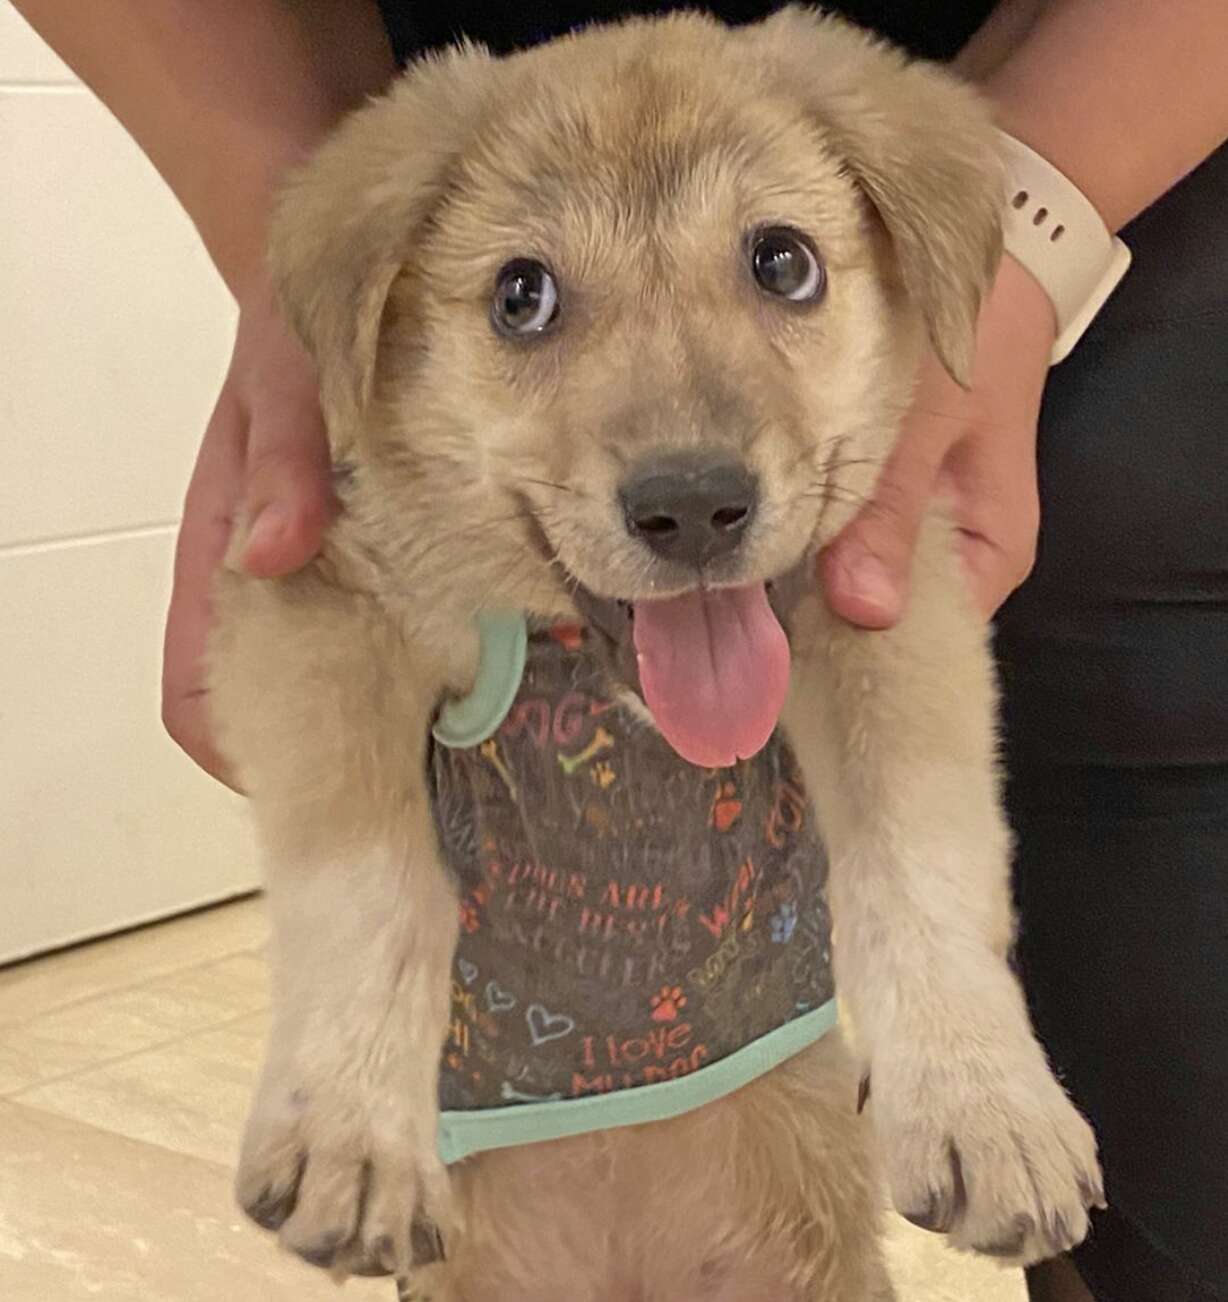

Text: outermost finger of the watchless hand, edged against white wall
xmin=161 ymin=387 xmax=242 ymax=786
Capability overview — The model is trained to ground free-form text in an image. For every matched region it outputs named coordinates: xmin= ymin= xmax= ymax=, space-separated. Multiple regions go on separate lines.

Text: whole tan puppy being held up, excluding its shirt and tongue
xmin=212 ymin=9 xmax=1100 ymax=1302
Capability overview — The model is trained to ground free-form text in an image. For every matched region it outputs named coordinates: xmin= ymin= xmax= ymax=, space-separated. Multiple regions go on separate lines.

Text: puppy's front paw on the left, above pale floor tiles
xmin=236 ymin=1074 xmax=453 ymax=1276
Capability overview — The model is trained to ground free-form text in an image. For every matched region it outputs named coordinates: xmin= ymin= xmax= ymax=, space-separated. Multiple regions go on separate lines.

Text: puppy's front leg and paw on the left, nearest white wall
xmin=214 ymin=575 xmax=457 ymax=1273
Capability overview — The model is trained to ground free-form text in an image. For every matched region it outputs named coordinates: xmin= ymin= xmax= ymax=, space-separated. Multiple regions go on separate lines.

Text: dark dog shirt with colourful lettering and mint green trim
xmin=428 ymin=616 xmax=835 ymax=1163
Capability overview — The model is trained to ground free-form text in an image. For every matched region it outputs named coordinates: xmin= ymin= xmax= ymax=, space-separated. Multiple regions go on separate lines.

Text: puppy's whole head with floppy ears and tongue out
xmin=275 ymin=12 xmax=996 ymax=762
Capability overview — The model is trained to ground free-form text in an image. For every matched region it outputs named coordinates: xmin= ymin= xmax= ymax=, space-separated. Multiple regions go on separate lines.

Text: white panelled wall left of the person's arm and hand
xmin=0 ymin=0 xmax=257 ymax=961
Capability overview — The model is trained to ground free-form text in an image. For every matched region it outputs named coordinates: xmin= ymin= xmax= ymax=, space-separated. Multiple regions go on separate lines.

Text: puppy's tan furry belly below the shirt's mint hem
xmin=432 ymin=1035 xmax=884 ymax=1302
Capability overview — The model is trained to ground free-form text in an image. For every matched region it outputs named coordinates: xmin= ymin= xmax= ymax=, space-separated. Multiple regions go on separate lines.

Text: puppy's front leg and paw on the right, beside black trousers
xmin=787 ymin=519 xmax=1103 ymax=1262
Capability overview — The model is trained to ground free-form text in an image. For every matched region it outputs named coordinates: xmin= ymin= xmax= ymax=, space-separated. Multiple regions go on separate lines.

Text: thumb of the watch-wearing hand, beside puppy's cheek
xmin=819 ymin=415 xmax=958 ymax=629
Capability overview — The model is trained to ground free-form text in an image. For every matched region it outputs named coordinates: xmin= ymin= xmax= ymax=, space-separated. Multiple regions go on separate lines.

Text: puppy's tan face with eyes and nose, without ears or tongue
xmin=414 ymin=69 xmax=908 ymax=603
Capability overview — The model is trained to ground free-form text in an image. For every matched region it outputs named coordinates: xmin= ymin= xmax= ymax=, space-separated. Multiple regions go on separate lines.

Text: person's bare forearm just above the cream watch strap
xmin=964 ymin=0 xmax=1228 ymax=230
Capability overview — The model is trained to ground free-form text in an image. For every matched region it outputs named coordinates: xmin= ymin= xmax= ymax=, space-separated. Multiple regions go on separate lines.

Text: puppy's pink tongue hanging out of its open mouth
xmin=634 ymin=583 xmax=789 ymax=768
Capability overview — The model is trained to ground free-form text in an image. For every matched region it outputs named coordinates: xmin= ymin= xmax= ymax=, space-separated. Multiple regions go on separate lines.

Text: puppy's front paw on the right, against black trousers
xmin=872 ymin=1032 xmax=1104 ymax=1264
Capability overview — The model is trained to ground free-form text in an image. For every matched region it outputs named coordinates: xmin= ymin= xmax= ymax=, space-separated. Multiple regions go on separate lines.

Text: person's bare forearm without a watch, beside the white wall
xmin=14 ymin=0 xmax=393 ymax=298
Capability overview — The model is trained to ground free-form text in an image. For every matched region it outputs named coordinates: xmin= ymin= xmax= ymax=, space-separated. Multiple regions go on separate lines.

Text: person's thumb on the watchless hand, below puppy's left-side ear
xmin=244 ymin=400 xmax=333 ymax=578
